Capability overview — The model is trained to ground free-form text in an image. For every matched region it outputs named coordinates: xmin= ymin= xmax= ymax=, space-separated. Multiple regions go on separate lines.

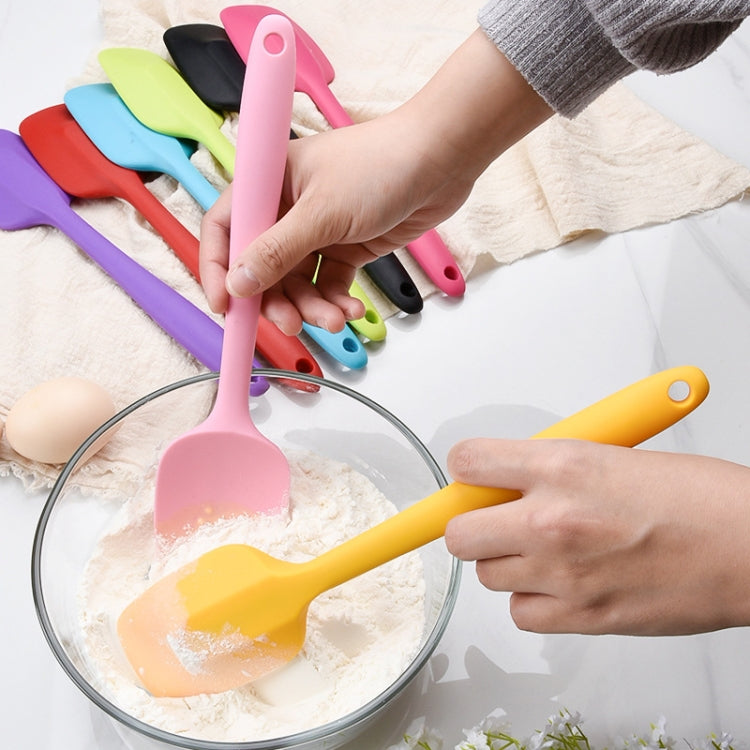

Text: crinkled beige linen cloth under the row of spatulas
xmin=0 ymin=0 xmax=750 ymax=496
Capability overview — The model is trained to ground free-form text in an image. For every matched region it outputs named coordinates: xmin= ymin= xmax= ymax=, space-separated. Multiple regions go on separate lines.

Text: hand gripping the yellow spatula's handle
xmin=445 ymin=439 xmax=750 ymax=635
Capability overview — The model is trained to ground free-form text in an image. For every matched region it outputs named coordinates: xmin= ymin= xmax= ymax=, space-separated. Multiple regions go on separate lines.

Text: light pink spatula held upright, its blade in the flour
xmin=154 ymin=15 xmax=295 ymax=535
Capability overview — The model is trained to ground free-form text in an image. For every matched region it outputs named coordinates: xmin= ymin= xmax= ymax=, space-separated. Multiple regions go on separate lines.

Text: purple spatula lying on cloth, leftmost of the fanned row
xmin=0 ymin=130 xmax=268 ymax=394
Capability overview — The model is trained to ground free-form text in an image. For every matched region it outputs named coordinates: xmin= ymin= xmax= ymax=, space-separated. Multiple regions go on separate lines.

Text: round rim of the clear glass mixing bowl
xmin=31 ymin=368 xmax=461 ymax=750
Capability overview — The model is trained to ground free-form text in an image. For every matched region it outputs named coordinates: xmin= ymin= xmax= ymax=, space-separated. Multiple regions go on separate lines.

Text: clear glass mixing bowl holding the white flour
xmin=32 ymin=369 xmax=460 ymax=750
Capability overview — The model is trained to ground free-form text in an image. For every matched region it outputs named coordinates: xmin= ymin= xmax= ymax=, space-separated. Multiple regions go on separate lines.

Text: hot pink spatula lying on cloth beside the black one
xmin=219 ymin=5 xmax=466 ymax=297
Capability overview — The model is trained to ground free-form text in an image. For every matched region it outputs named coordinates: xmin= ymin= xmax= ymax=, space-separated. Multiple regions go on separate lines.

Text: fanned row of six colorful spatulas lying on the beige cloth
xmin=0 ymin=0 xmax=465 ymax=394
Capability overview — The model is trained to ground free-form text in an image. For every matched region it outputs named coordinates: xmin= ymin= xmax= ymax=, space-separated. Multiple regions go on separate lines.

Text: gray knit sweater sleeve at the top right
xmin=478 ymin=0 xmax=750 ymax=117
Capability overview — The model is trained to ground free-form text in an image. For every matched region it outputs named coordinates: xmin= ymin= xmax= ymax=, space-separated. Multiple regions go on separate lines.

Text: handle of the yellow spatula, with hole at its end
xmin=302 ymin=366 xmax=708 ymax=593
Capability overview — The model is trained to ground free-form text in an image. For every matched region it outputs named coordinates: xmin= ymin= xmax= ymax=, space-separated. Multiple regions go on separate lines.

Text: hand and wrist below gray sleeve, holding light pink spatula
xmin=200 ymin=30 xmax=551 ymax=334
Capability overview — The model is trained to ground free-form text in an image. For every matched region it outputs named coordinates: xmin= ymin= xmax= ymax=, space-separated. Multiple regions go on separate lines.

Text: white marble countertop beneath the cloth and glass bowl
xmin=0 ymin=0 xmax=750 ymax=750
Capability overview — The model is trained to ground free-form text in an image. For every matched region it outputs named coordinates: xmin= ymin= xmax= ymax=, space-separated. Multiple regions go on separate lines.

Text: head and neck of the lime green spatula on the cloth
xmin=99 ymin=47 xmax=238 ymax=176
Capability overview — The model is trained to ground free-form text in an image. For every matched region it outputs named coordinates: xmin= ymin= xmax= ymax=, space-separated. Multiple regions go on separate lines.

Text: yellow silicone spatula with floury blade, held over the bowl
xmin=117 ymin=367 xmax=708 ymax=696
